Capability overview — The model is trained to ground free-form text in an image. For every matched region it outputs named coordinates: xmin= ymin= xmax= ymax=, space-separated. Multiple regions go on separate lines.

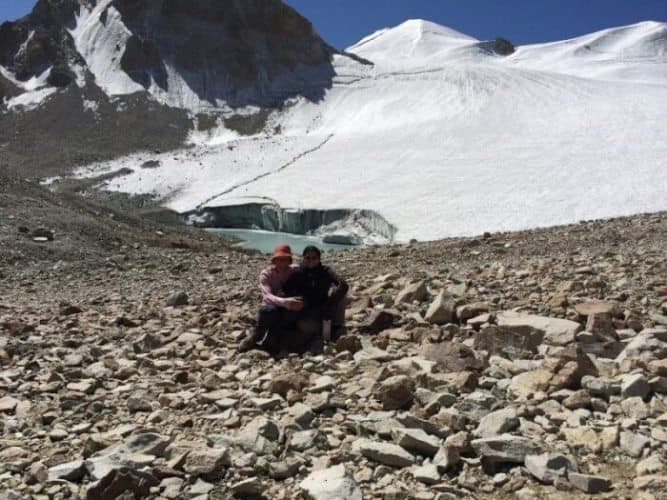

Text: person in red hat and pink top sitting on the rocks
xmin=239 ymin=244 xmax=303 ymax=352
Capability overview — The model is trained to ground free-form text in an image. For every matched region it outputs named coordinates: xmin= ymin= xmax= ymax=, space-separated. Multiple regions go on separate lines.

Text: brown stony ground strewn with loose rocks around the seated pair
xmin=0 ymin=175 xmax=667 ymax=500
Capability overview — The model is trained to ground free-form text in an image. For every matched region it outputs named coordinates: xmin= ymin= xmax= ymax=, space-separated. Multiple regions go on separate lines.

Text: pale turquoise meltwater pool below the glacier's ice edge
xmin=207 ymin=228 xmax=359 ymax=255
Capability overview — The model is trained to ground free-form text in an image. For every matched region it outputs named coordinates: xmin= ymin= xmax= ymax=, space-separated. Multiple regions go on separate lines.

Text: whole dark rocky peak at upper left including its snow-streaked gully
xmin=0 ymin=0 xmax=334 ymax=107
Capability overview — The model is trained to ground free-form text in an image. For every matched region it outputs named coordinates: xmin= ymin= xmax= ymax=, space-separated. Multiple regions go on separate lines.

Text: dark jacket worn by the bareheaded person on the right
xmin=284 ymin=264 xmax=349 ymax=309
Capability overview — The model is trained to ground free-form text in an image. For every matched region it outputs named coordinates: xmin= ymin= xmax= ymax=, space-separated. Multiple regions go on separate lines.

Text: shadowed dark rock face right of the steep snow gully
xmin=112 ymin=0 xmax=340 ymax=105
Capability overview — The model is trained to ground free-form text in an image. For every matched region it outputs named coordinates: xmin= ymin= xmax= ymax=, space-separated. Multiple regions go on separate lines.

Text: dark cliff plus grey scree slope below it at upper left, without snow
xmin=0 ymin=0 xmax=342 ymax=177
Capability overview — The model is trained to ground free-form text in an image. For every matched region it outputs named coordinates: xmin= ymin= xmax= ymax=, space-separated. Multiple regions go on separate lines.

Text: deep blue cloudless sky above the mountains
xmin=0 ymin=0 xmax=667 ymax=48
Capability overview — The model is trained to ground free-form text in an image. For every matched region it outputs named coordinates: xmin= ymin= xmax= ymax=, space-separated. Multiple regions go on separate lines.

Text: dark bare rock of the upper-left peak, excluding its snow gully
xmin=0 ymin=0 xmax=334 ymax=106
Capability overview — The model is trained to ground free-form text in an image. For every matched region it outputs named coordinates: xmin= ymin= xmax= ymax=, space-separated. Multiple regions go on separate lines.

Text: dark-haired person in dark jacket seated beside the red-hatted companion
xmin=285 ymin=246 xmax=349 ymax=341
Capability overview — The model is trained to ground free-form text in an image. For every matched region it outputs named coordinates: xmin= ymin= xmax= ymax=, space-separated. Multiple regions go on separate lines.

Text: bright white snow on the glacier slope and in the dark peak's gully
xmin=61 ymin=17 xmax=667 ymax=241
